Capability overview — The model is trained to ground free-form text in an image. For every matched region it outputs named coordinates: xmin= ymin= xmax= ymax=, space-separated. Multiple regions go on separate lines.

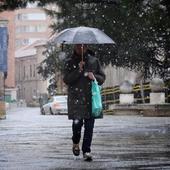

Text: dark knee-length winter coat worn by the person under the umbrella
xmin=63 ymin=51 xmax=105 ymax=119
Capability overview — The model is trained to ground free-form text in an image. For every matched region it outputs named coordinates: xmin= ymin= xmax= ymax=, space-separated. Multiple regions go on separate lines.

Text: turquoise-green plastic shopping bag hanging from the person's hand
xmin=91 ymin=80 xmax=102 ymax=118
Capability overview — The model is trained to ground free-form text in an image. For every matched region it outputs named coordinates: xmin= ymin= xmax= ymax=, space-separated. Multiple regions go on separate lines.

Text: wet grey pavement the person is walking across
xmin=0 ymin=108 xmax=170 ymax=170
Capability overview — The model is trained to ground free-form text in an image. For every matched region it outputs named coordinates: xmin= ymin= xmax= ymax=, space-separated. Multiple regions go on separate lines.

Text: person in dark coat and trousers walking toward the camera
xmin=63 ymin=44 xmax=105 ymax=161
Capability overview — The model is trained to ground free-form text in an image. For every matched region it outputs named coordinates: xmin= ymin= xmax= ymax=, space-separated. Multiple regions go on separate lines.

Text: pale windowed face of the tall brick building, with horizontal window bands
xmin=15 ymin=8 xmax=51 ymax=49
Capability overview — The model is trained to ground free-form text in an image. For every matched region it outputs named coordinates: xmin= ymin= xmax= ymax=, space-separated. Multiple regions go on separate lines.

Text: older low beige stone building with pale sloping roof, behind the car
xmin=15 ymin=41 xmax=48 ymax=104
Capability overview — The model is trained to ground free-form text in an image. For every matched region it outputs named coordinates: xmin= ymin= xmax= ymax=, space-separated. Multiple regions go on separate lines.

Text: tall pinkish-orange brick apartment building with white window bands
xmin=0 ymin=5 xmax=51 ymax=102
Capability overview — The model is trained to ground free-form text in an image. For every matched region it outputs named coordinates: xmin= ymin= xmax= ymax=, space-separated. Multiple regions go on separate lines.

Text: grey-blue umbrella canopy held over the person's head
xmin=53 ymin=26 xmax=115 ymax=44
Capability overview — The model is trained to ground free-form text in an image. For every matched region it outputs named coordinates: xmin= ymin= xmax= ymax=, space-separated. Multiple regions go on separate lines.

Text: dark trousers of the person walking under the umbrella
xmin=72 ymin=118 xmax=95 ymax=153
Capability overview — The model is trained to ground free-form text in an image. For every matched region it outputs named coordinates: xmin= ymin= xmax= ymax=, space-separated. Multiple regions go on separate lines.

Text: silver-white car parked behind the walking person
xmin=41 ymin=95 xmax=68 ymax=115
